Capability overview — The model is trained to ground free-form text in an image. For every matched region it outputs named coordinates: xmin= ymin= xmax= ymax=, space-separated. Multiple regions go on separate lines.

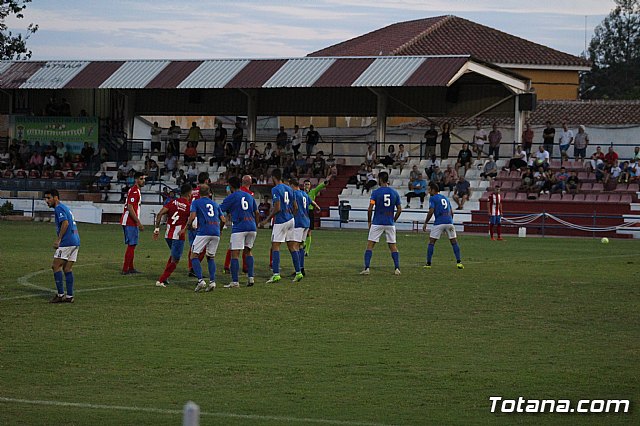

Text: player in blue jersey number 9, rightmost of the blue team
xmin=422 ymin=182 xmax=464 ymax=269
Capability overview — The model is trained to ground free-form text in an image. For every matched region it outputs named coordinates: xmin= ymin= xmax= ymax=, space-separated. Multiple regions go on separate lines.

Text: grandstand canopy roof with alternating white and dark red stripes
xmin=0 ymin=55 xmax=525 ymax=90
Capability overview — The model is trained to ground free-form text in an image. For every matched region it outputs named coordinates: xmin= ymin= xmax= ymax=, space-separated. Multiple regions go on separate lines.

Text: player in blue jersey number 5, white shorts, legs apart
xmin=360 ymin=172 xmax=402 ymax=275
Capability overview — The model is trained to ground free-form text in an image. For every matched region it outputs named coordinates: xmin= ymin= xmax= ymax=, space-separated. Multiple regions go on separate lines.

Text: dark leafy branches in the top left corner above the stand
xmin=0 ymin=0 xmax=38 ymax=60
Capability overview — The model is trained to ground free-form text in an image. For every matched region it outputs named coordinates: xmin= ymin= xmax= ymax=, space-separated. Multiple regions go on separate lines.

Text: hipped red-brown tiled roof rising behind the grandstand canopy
xmin=309 ymin=15 xmax=589 ymax=67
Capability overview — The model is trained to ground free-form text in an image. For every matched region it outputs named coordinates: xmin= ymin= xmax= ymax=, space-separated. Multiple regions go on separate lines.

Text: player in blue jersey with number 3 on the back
xmin=182 ymin=184 xmax=224 ymax=291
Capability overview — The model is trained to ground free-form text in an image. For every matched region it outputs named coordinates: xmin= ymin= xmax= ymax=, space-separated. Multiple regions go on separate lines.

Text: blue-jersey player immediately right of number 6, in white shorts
xmin=260 ymin=169 xmax=303 ymax=283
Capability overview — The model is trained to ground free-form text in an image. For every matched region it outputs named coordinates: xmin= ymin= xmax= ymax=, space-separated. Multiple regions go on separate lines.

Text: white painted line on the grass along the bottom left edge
xmin=0 ymin=397 xmax=396 ymax=426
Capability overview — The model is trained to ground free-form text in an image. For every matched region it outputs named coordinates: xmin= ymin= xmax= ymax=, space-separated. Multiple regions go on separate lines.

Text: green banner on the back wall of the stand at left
xmin=13 ymin=116 xmax=98 ymax=153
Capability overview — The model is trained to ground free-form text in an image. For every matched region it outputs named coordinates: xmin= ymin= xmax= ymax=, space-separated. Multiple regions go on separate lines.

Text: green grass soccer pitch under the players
xmin=0 ymin=222 xmax=640 ymax=425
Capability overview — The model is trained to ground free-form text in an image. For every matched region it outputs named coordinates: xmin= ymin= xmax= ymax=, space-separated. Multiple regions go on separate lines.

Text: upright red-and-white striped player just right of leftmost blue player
xmin=120 ymin=172 xmax=146 ymax=275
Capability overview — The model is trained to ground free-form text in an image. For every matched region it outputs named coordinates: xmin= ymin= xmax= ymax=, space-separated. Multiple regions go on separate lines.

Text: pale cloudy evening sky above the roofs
xmin=7 ymin=0 xmax=615 ymax=60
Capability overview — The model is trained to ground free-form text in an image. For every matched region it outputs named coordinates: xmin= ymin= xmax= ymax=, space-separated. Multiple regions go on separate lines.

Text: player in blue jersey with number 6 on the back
xmin=220 ymin=176 xmax=260 ymax=288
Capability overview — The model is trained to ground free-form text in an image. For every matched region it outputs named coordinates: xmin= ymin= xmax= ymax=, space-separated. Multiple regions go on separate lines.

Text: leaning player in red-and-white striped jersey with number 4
xmin=153 ymin=183 xmax=193 ymax=287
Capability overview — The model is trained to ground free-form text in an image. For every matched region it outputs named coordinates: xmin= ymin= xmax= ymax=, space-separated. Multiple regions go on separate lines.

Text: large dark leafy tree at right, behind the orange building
xmin=581 ymin=0 xmax=640 ymax=99
